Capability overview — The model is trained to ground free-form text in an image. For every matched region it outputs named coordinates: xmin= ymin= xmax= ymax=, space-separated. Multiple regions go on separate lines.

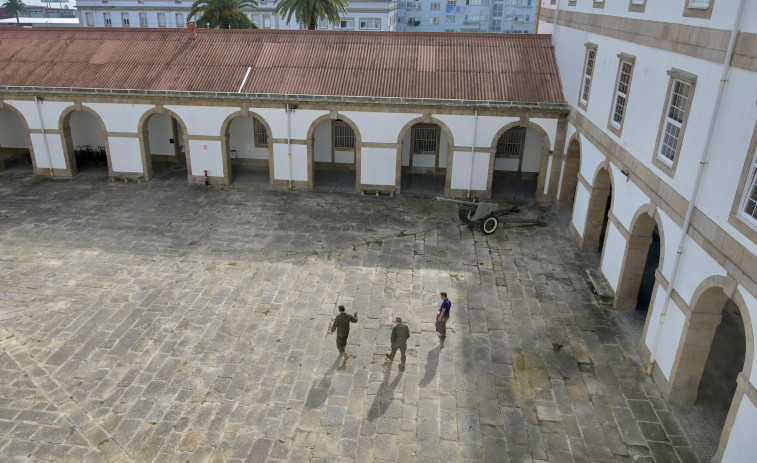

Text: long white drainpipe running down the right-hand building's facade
xmin=647 ymin=0 xmax=745 ymax=375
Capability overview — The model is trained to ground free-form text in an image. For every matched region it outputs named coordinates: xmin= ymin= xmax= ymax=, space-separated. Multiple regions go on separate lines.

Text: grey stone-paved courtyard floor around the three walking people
xmin=0 ymin=173 xmax=696 ymax=463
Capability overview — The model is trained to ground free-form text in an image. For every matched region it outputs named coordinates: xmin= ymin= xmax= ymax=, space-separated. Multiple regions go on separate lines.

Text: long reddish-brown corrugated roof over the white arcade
xmin=0 ymin=27 xmax=565 ymax=103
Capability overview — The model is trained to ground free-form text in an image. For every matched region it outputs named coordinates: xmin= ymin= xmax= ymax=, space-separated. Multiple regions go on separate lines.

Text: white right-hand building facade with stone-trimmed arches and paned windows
xmin=539 ymin=0 xmax=757 ymax=462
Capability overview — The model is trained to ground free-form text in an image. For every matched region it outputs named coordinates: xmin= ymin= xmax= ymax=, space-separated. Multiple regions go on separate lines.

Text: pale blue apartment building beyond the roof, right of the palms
xmin=397 ymin=0 xmax=538 ymax=34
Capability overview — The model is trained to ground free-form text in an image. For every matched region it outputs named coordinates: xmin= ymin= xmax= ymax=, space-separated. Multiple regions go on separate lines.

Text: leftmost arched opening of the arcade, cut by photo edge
xmin=0 ymin=107 xmax=34 ymax=173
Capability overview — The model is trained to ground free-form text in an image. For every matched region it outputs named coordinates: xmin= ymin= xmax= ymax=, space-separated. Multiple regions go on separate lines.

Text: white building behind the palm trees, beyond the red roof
xmin=76 ymin=0 xmax=397 ymax=31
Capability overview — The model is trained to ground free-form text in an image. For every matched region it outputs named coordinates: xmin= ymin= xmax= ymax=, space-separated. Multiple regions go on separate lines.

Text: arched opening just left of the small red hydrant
xmin=139 ymin=110 xmax=190 ymax=183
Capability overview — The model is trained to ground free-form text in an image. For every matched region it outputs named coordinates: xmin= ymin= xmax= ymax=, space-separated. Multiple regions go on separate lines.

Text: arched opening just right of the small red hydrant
xmin=223 ymin=114 xmax=273 ymax=186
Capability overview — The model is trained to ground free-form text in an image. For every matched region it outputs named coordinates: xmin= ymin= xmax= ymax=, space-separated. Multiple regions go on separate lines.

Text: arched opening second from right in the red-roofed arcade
xmin=400 ymin=121 xmax=452 ymax=196
